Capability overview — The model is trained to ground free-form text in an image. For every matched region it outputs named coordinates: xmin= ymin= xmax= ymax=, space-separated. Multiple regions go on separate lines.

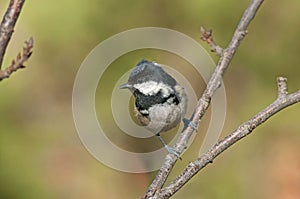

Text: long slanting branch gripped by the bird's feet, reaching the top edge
xmin=143 ymin=0 xmax=263 ymax=198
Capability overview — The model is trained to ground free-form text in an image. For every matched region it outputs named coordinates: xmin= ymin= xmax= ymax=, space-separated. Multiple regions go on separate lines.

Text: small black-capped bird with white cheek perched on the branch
xmin=120 ymin=59 xmax=192 ymax=156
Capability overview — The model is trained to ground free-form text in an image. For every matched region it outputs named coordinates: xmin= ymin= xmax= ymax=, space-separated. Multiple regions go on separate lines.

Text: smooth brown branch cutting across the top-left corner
xmin=0 ymin=0 xmax=25 ymax=69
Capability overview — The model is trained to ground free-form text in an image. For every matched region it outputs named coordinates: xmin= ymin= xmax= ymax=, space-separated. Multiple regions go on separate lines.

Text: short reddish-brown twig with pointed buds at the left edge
xmin=0 ymin=38 xmax=33 ymax=81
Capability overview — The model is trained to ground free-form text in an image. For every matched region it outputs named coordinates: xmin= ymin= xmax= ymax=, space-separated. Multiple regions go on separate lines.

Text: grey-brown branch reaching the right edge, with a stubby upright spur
xmin=153 ymin=77 xmax=300 ymax=198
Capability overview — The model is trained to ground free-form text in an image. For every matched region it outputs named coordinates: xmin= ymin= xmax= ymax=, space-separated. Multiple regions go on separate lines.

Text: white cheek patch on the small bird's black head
xmin=133 ymin=81 xmax=172 ymax=97
